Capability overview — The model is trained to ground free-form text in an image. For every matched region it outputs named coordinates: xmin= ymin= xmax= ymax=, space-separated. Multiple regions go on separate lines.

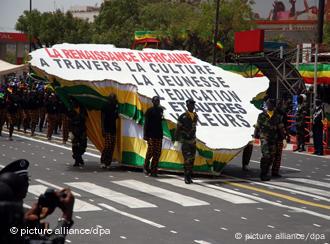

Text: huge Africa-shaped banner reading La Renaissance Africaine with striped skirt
xmin=30 ymin=44 xmax=269 ymax=172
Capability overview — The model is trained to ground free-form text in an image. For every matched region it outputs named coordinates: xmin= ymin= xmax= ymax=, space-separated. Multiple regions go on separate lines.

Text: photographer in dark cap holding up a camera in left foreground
xmin=0 ymin=159 xmax=74 ymax=244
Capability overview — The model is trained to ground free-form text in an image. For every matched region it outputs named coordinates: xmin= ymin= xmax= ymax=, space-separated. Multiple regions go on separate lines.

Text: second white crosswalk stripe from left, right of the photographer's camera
xmin=65 ymin=182 xmax=157 ymax=208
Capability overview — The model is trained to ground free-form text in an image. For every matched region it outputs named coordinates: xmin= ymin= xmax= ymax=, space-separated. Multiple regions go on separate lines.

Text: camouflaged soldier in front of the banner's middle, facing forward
xmin=175 ymin=98 xmax=198 ymax=184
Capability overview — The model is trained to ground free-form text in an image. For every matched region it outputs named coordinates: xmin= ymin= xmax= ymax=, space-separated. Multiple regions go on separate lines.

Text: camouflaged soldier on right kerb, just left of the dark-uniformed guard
xmin=295 ymin=95 xmax=307 ymax=152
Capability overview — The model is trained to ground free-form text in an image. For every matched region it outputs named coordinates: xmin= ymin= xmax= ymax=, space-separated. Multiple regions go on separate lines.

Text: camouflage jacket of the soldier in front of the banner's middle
xmin=175 ymin=112 xmax=198 ymax=143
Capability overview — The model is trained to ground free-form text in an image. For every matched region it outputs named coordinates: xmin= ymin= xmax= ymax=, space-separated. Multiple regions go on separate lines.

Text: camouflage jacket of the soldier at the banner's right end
xmin=254 ymin=111 xmax=285 ymax=143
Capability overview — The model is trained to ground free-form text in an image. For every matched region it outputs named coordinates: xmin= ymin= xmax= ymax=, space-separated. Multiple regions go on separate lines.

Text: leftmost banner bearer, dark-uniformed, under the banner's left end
xmin=70 ymin=101 xmax=87 ymax=167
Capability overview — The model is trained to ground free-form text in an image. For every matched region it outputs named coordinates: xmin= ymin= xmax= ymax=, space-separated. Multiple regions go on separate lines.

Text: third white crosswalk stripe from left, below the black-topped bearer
xmin=113 ymin=180 xmax=209 ymax=207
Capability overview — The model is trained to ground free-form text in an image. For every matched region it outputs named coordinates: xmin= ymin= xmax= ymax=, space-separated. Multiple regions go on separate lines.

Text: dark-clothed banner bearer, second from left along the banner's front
xmin=101 ymin=94 xmax=119 ymax=169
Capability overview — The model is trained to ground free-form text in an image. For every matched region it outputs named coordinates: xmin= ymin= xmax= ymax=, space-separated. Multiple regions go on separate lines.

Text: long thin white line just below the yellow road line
xmin=200 ymin=184 xmax=330 ymax=220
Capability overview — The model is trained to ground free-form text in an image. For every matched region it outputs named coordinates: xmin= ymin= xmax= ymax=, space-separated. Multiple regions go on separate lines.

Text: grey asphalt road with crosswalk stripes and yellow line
xmin=0 ymin=129 xmax=330 ymax=244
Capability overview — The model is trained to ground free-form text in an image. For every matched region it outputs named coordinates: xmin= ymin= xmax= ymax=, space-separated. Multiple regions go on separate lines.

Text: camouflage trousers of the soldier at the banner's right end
xmin=260 ymin=139 xmax=277 ymax=176
